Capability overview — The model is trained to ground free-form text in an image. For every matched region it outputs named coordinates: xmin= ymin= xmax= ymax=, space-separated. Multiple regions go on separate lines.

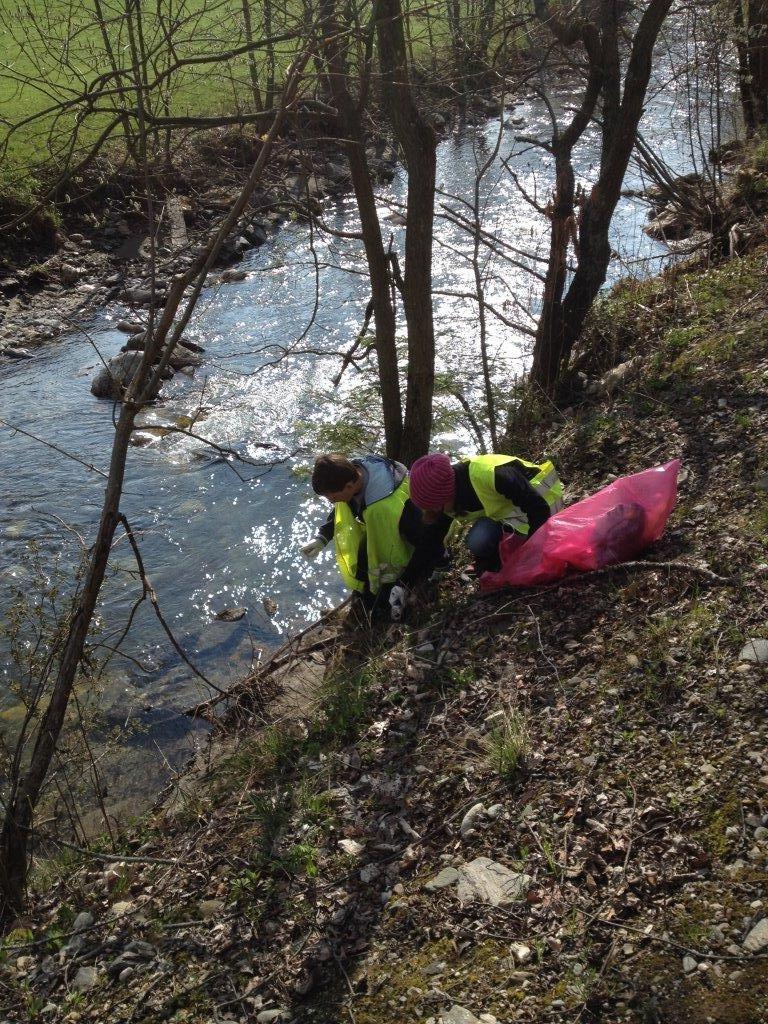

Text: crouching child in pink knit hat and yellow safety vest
xmin=411 ymin=454 xmax=563 ymax=574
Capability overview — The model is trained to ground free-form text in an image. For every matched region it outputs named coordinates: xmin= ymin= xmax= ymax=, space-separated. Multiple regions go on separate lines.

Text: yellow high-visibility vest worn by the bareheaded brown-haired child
xmin=334 ymin=478 xmax=414 ymax=594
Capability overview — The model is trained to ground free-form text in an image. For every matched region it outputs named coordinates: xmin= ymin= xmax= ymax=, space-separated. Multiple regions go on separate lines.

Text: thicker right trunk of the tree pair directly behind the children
xmin=376 ymin=0 xmax=437 ymax=463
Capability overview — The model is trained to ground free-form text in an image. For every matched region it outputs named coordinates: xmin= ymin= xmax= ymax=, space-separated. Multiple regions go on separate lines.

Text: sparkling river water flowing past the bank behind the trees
xmin=0 ymin=61 xmax=741 ymax=815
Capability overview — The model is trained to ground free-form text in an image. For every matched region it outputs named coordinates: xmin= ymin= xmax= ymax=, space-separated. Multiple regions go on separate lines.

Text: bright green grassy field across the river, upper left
xmin=0 ymin=0 xmax=303 ymax=185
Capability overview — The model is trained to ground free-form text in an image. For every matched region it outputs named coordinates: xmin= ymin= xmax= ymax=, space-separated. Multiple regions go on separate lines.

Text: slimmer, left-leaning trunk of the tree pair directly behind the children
xmin=321 ymin=0 xmax=402 ymax=459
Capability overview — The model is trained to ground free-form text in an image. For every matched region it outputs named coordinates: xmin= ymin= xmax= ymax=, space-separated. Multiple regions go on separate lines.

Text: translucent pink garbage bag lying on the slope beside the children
xmin=480 ymin=459 xmax=680 ymax=590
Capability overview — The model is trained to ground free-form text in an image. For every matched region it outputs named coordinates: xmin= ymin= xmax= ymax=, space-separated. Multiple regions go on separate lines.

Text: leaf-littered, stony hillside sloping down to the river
xmin=1 ymin=243 xmax=768 ymax=1024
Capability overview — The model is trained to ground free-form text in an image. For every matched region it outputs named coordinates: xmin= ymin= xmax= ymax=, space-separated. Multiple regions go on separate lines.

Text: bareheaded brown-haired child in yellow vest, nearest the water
xmin=301 ymin=455 xmax=444 ymax=621
